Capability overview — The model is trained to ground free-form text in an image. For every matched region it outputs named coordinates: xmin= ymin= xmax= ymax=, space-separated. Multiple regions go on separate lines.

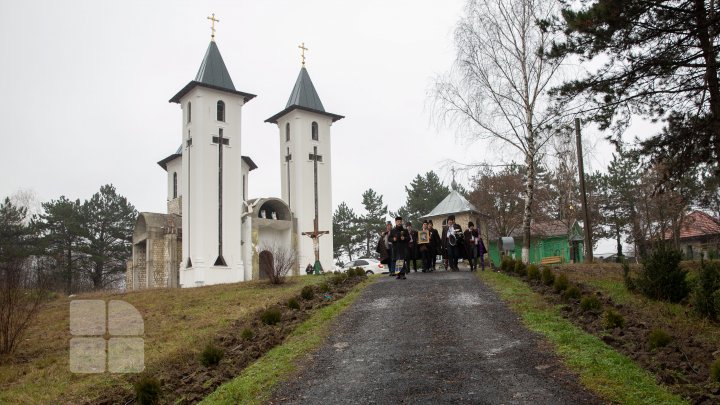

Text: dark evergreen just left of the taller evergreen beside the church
xmin=33 ymin=196 xmax=87 ymax=294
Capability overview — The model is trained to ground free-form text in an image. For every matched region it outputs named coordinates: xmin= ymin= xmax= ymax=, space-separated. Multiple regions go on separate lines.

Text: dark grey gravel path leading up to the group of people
xmin=271 ymin=272 xmax=601 ymax=404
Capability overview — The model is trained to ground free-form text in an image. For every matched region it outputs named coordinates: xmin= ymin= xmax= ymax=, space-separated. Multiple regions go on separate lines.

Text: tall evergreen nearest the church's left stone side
xmin=82 ymin=184 xmax=138 ymax=289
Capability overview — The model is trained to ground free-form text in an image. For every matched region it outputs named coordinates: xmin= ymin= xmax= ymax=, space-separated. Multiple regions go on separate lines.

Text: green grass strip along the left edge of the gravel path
xmin=200 ymin=277 xmax=377 ymax=405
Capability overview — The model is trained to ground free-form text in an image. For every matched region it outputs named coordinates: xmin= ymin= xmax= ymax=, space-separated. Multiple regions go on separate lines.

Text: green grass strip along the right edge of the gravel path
xmin=477 ymin=272 xmax=688 ymax=404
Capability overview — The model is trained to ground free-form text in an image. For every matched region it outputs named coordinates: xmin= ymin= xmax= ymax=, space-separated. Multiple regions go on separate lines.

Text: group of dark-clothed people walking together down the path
xmin=375 ymin=215 xmax=487 ymax=280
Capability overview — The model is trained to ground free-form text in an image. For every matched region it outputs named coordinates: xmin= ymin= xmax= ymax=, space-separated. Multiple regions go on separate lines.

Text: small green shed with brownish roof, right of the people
xmin=488 ymin=220 xmax=585 ymax=264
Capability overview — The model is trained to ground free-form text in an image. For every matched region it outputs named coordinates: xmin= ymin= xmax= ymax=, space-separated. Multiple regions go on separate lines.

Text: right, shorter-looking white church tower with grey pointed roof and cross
xmin=265 ymin=49 xmax=344 ymax=270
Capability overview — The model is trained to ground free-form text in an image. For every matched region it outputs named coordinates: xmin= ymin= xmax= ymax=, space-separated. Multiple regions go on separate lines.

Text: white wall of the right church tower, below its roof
xmin=277 ymin=109 xmax=334 ymax=274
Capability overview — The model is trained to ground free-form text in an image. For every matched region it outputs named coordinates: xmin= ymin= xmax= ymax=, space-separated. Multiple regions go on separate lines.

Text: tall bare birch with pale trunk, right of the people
xmin=433 ymin=0 xmax=562 ymax=263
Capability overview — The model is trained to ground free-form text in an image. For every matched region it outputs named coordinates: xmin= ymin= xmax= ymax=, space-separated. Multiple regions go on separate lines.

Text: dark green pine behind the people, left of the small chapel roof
xmin=397 ymin=171 xmax=450 ymax=224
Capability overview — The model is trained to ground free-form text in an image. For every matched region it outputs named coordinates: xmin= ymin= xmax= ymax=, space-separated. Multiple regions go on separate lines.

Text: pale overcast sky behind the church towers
xmin=0 ymin=0 xmax=640 ymax=252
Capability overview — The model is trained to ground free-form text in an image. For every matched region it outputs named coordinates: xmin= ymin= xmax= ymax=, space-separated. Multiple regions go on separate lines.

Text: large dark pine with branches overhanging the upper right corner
xmin=551 ymin=0 xmax=720 ymax=182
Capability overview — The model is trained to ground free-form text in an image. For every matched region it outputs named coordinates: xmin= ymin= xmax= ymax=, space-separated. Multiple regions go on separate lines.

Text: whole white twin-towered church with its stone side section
xmin=126 ymin=25 xmax=344 ymax=290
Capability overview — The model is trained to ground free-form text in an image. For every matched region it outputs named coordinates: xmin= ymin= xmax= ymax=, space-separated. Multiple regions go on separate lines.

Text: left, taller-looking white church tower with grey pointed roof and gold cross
xmin=170 ymin=28 xmax=255 ymax=287
